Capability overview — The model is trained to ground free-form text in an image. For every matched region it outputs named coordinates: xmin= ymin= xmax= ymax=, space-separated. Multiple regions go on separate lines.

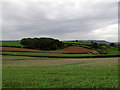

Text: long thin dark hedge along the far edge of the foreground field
xmin=0 ymin=54 xmax=120 ymax=58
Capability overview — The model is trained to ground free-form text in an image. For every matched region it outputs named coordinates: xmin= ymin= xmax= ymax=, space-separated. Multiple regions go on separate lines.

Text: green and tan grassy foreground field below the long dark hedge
xmin=2 ymin=56 xmax=118 ymax=88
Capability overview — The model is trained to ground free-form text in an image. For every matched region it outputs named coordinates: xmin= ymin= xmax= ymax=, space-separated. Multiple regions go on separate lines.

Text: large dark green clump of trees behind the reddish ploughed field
xmin=20 ymin=37 xmax=64 ymax=50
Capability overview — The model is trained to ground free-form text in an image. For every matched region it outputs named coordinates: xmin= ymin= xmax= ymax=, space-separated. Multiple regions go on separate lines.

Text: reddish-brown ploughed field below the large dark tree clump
xmin=2 ymin=46 xmax=94 ymax=53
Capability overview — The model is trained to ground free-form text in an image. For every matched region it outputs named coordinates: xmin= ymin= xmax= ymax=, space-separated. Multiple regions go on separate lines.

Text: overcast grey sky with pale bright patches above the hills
xmin=0 ymin=0 xmax=118 ymax=41
